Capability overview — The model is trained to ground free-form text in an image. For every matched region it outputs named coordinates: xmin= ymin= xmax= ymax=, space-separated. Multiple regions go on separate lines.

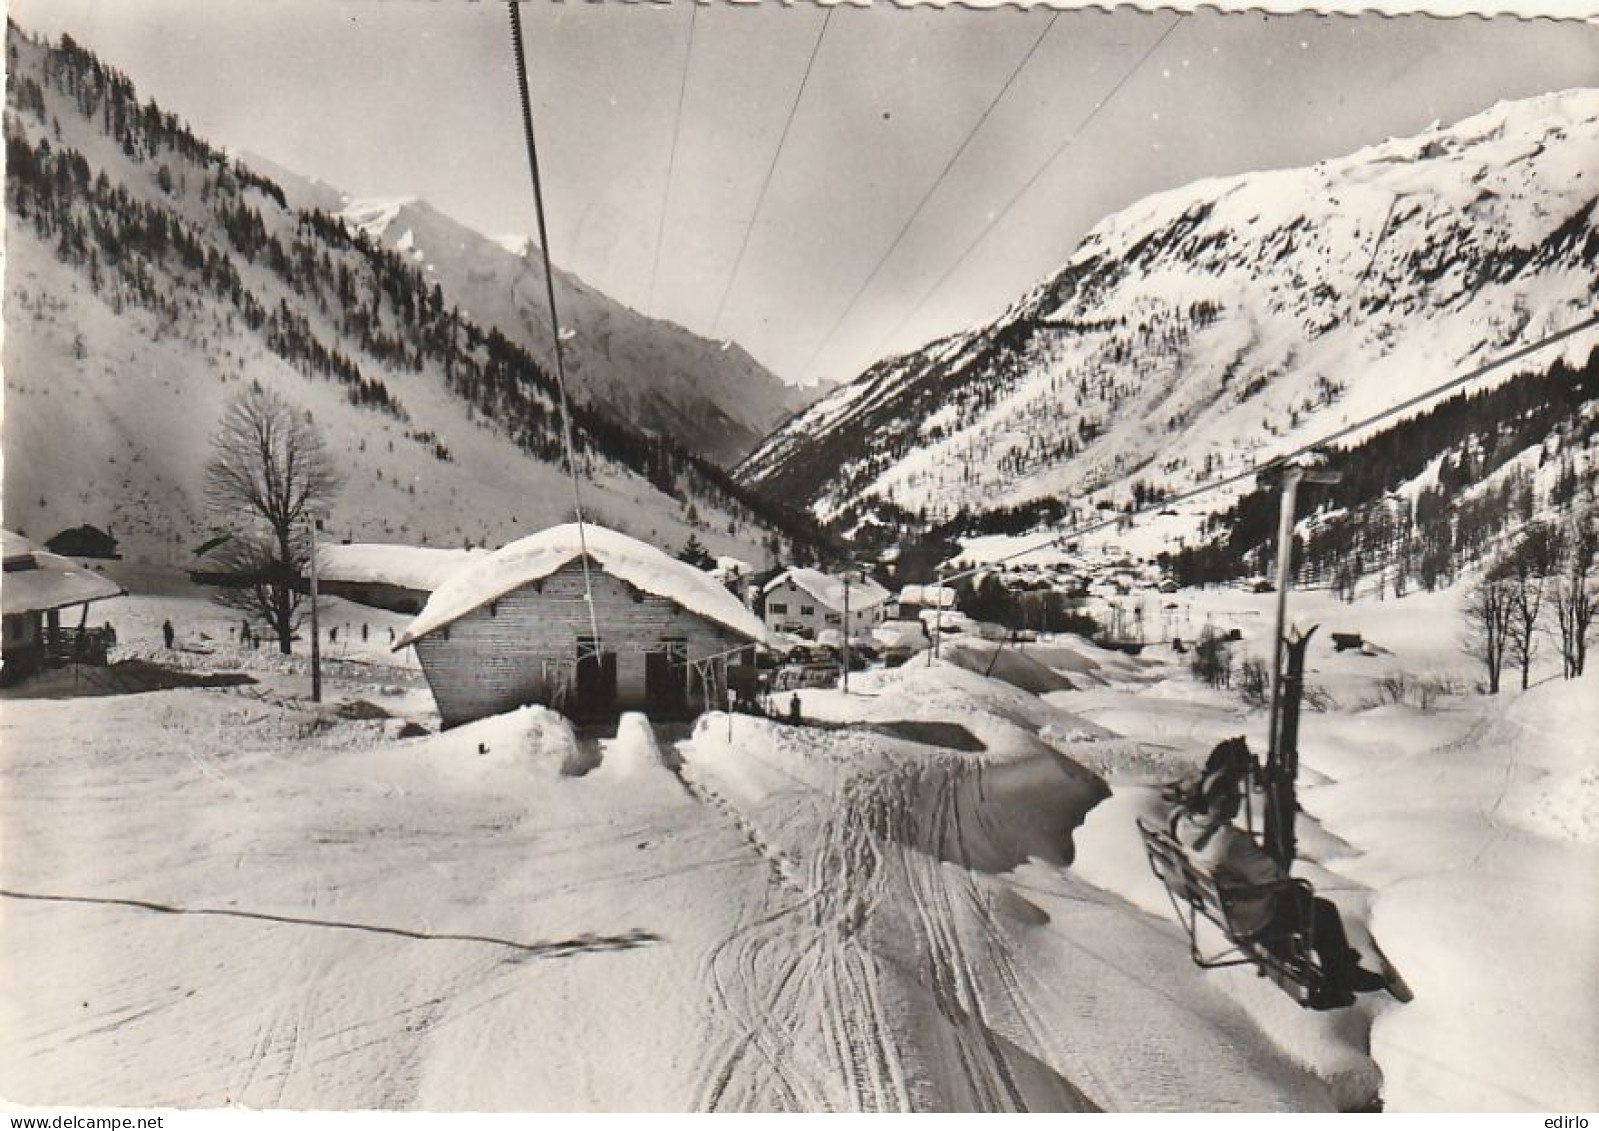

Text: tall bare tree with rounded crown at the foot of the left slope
xmin=205 ymin=384 xmax=341 ymax=654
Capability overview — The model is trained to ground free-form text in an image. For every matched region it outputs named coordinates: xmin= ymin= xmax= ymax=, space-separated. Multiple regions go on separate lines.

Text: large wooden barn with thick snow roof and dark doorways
xmin=395 ymin=523 xmax=768 ymax=726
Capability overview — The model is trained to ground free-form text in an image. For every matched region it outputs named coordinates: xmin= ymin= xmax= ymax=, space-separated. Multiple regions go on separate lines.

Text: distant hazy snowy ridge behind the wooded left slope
xmin=256 ymin=153 xmax=822 ymax=466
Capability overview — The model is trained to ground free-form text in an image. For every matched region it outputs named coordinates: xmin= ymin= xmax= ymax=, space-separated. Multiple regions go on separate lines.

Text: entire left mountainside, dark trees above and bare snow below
xmin=3 ymin=30 xmax=812 ymax=565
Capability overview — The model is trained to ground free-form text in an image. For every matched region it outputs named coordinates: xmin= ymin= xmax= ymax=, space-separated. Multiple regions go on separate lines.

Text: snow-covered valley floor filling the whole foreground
xmin=0 ymin=573 xmax=1599 ymax=1110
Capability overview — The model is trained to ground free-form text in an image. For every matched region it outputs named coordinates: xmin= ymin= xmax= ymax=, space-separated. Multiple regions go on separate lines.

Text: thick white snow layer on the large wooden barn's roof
xmin=395 ymin=523 xmax=768 ymax=649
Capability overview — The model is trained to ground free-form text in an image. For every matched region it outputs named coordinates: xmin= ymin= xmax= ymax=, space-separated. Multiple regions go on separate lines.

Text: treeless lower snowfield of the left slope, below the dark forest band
xmin=3 ymin=230 xmax=740 ymax=566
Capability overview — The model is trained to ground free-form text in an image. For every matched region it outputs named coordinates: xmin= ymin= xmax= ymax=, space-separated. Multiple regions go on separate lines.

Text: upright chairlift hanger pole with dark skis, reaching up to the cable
xmin=1257 ymin=453 xmax=1340 ymax=869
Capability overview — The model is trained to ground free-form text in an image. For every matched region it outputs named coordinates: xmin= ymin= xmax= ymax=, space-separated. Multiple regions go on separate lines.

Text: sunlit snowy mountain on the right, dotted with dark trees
xmin=739 ymin=90 xmax=1599 ymax=537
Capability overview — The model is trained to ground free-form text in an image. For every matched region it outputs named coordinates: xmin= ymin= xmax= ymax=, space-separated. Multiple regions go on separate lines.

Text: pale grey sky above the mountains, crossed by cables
xmin=11 ymin=0 xmax=1599 ymax=381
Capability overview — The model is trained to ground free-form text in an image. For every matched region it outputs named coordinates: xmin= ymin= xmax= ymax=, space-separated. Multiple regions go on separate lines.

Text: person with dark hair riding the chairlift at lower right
xmin=1170 ymin=758 xmax=1385 ymax=1001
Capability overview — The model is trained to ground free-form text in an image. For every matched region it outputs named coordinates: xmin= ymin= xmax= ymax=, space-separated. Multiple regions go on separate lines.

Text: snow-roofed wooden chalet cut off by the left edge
xmin=0 ymin=531 xmax=123 ymax=683
